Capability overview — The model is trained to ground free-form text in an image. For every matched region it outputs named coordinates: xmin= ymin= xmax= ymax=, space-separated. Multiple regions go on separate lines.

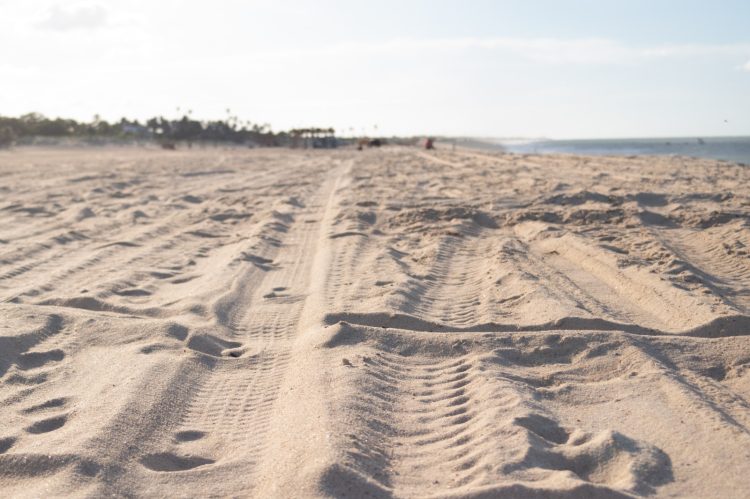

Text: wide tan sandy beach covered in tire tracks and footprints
xmin=0 ymin=148 xmax=750 ymax=498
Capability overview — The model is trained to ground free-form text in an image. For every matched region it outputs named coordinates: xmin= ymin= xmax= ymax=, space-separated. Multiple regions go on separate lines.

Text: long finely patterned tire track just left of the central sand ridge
xmin=122 ymin=161 xmax=346 ymax=493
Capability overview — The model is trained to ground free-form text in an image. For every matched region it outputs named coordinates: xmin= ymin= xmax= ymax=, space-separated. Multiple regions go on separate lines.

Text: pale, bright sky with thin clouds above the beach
xmin=0 ymin=0 xmax=750 ymax=139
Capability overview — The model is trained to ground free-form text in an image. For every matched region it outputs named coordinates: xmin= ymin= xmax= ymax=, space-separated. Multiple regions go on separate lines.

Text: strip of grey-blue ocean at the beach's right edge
xmin=474 ymin=137 xmax=750 ymax=165
